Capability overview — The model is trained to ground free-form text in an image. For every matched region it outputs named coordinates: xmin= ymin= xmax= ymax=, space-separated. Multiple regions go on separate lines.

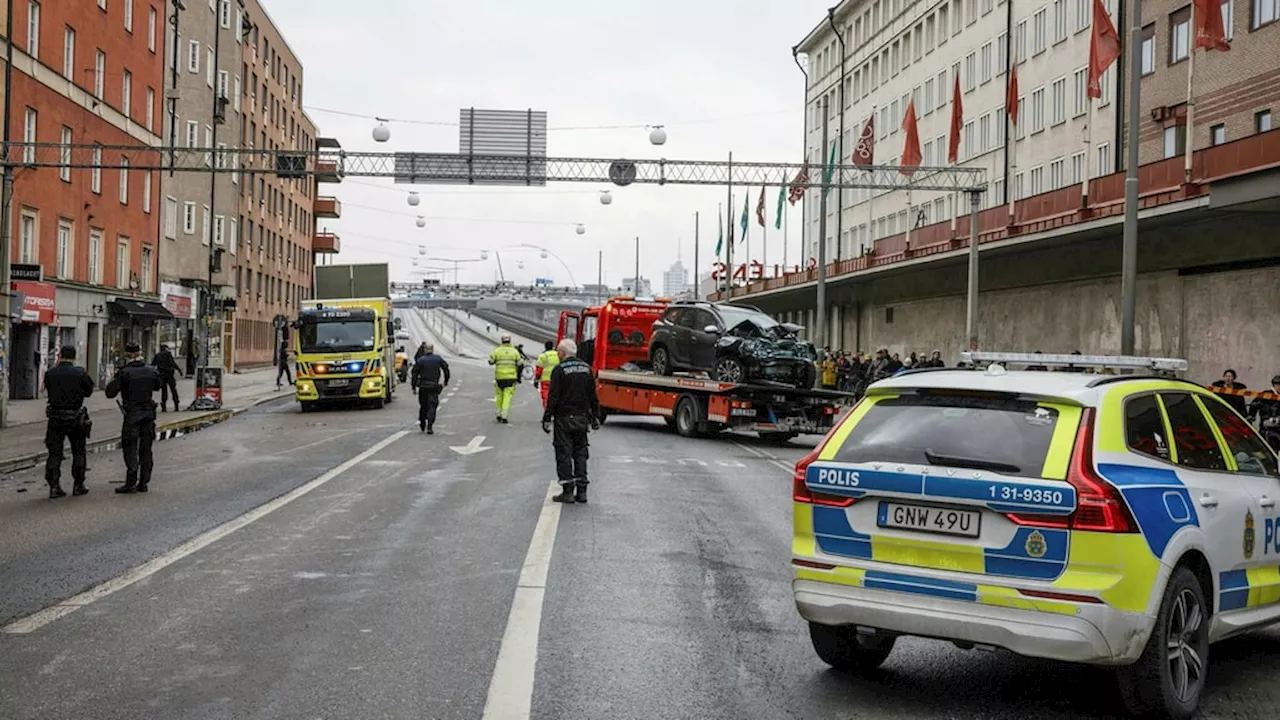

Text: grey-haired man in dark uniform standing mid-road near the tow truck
xmin=543 ymin=340 xmax=600 ymax=502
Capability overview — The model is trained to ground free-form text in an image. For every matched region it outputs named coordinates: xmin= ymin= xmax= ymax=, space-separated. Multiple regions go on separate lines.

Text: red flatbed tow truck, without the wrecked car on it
xmin=556 ymin=296 xmax=855 ymax=443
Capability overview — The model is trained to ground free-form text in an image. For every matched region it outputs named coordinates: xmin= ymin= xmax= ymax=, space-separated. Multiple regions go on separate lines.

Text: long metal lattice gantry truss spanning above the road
xmin=10 ymin=142 xmax=987 ymax=192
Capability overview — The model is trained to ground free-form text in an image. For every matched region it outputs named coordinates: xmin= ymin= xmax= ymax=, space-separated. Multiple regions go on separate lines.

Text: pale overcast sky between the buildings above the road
xmin=265 ymin=0 xmax=833 ymax=291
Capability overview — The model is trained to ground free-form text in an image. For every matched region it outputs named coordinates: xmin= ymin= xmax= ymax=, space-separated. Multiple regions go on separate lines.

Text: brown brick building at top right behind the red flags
xmin=1139 ymin=0 xmax=1280 ymax=163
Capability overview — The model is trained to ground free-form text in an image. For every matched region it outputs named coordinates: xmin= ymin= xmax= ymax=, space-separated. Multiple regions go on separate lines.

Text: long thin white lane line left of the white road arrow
xmin=0 ymin=430 xmax=408 ymax=635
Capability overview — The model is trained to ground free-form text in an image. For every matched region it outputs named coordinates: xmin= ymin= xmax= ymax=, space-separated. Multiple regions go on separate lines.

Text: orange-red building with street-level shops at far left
xmin=6 ymin=0 xmax=168 ymax=398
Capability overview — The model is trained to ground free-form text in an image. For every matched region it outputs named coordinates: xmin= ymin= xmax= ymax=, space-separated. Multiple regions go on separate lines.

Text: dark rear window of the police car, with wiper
xmin=835 ymin=396 xmax=1057 ymax=478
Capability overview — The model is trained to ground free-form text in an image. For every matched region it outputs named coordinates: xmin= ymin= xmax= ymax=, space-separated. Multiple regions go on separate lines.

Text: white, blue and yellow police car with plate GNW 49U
xmin=792 ymin=352 xmax=1280 ymax=719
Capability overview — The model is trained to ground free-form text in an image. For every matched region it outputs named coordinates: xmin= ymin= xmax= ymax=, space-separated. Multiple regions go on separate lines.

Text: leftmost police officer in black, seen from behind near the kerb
xmin=45 ymin=345 xmax=93 ymax=500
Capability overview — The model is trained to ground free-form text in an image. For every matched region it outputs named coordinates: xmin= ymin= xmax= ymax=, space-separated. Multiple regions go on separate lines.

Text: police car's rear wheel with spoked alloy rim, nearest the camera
xmin=1116 ymin=568 xmax=1210 ymax=720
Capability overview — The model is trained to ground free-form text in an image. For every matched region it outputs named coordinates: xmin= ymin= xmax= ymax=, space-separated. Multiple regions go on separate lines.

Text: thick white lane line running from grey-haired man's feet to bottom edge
xmin=481 ymin=483 xmax=561 ymax=720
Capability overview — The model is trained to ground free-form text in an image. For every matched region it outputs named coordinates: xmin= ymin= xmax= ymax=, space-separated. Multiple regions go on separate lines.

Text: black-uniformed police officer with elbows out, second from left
xmin=106 ymin=342 xmax=160 ymax=495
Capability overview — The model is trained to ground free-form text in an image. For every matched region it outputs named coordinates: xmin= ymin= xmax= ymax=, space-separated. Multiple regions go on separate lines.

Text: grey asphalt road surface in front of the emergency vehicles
xmin=0 ymin=356 xmax=1280 ymax=720
